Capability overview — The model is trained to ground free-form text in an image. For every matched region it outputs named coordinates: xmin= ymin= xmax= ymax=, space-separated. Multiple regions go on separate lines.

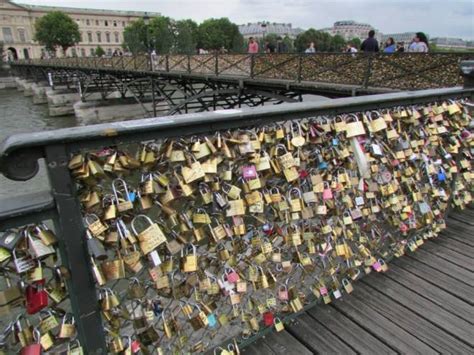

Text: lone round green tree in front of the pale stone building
xmin=35 ymin=11 xmax=81 ymax=53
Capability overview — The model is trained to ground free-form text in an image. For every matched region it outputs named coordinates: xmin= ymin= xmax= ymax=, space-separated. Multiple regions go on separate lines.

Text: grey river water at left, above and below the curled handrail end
xmin=0 ymin=89 xmax=76 ymax=199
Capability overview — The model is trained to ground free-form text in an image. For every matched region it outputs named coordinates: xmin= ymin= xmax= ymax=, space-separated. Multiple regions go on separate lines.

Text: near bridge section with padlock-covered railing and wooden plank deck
xmin=0 ymin=57 xmax=474 ymax=355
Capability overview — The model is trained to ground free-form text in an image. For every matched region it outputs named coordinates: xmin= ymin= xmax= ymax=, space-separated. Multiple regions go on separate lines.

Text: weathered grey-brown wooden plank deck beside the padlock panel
xmin=241 ymin=209 xmax=474 ymax=355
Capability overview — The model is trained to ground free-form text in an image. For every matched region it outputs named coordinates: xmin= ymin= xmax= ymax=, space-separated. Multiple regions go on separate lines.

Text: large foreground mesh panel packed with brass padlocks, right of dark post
xmin=65 ymin=99 xmax=472 ymax=353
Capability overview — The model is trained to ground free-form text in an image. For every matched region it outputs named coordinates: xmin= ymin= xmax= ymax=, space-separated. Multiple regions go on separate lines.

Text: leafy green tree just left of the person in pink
xmin=198 ymin=18 xmax=244 ymax=52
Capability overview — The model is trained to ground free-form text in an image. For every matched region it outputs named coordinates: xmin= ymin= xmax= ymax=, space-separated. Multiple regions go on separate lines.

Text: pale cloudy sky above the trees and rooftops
xmin=15 ymin=0 xmax=474 ymax=40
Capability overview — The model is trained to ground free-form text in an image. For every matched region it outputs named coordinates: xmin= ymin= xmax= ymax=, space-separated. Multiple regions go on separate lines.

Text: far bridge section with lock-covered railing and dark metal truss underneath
xmin=12 ymin=53 xmax=473 ymax=117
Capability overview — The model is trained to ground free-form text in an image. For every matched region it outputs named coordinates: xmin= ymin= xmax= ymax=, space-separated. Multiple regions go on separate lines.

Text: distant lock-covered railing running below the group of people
xmin=14 ymin=53 xmax=474 ymax=90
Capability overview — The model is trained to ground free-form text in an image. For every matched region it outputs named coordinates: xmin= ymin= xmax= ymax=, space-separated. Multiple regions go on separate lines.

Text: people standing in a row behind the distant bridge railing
xmin=247 ymin=30 xmax=429 ymax=54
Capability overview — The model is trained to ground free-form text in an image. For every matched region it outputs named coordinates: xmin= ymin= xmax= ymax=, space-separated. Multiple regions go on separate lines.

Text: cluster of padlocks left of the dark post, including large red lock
xmin=0 ymin=224 xmax=81 ymax=355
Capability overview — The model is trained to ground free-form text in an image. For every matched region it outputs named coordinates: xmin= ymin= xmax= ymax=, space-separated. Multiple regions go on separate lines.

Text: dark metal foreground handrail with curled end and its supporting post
xmin=0 ymin=82 xmax=474 ymax=354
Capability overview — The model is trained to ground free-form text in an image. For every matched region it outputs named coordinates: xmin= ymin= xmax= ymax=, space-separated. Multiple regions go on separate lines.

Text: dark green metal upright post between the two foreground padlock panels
xmin=45 ymin=145 xmax=107 ymax=354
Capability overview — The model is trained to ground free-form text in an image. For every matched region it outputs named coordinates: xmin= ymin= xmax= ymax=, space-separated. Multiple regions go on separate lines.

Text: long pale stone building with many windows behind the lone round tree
xmin=0 ymin=0 xmax=160 ymax=59
